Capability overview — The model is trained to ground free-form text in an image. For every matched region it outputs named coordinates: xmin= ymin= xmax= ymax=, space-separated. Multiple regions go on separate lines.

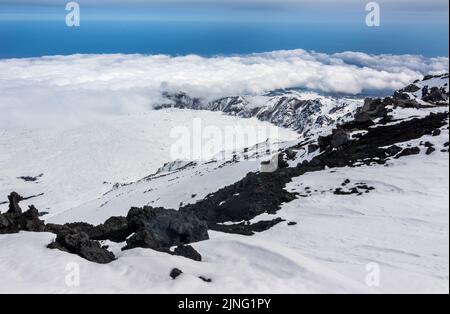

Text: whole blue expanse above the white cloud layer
xmin=0 ymin=0 xmax=448 ymax=58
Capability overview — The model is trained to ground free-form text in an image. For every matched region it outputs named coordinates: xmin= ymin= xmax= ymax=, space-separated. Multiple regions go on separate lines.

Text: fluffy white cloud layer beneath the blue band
xmin=0 ymin=50 xmax=449 ymax=124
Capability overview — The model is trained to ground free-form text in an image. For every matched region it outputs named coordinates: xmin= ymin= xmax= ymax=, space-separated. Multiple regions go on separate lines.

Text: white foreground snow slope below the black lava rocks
xmin=0 ymin=123 xmax=449 ymax=293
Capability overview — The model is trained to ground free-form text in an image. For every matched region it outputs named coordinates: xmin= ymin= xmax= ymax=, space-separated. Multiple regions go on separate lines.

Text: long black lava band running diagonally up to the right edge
xmin=180 ymin=113 xmax=448 ymax=233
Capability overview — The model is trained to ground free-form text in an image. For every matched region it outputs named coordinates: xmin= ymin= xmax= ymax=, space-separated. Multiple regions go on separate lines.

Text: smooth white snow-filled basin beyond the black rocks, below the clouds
xmin=0 ymin=109 xmax=298 ymax=218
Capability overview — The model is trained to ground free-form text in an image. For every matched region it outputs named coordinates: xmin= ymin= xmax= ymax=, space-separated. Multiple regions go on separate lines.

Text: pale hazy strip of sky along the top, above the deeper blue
xmin=0 ymin=0 xmax=448 ymax=23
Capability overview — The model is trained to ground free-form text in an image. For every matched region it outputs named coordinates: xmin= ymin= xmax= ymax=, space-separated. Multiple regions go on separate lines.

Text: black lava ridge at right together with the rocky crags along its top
xmin=175 ymin=73 xmax=448 ymax=228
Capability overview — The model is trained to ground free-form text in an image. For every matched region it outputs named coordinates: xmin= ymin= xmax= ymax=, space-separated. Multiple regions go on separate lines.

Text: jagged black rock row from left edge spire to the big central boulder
xmin=0 ymin=192 xmax=209 ymax=264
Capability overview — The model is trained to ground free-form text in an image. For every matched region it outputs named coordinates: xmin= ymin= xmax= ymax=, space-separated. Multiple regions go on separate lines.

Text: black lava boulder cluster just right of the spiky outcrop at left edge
xmin=46 ymin=207 xmax=209 ymax=264
